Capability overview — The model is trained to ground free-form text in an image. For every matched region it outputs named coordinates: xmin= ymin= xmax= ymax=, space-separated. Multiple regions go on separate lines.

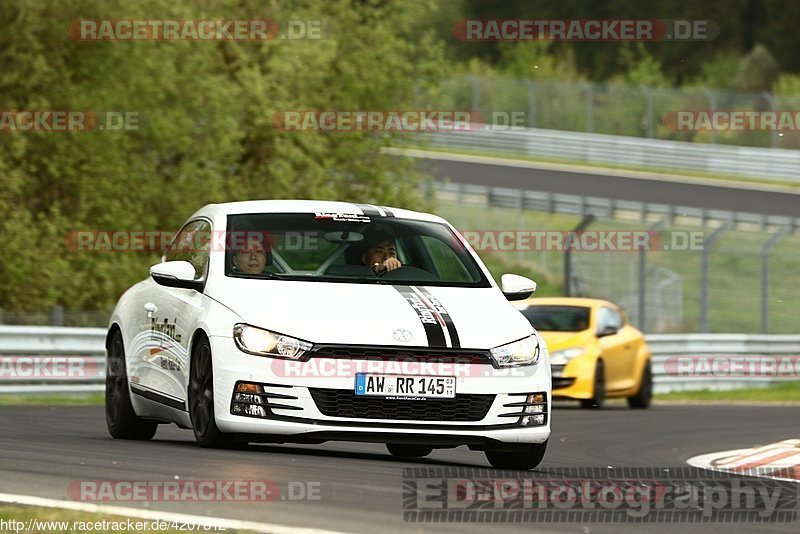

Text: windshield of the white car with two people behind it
xmin=225 ymin=213 xmax=489 ymax=287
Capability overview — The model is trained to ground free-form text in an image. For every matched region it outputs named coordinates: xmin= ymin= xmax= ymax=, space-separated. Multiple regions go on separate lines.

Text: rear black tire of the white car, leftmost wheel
xmin=106 ymin=330 xmax=158 ymax=440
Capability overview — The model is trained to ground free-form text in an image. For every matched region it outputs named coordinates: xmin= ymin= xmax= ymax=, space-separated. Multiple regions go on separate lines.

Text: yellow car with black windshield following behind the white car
xmin=515 ymin=297 xmax=653 ymax=408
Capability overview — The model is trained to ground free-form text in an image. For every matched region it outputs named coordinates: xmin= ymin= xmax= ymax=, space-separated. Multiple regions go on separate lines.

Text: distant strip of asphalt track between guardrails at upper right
xmin=419 ymin=155 xmax=800 ymax=217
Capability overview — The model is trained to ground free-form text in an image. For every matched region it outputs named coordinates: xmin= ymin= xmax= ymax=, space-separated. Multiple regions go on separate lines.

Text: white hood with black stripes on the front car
xmin=208 ymin=278 xmax=533 ymax=349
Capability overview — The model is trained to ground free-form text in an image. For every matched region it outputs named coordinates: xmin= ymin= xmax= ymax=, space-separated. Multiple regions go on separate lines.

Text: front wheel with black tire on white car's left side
xmin=189 ymin=337 xmax=239 ymax=449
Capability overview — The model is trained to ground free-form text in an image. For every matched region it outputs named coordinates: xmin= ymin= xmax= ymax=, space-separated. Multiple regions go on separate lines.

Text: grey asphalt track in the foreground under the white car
xmin=0 ymin=403 xmax=800 ymax=534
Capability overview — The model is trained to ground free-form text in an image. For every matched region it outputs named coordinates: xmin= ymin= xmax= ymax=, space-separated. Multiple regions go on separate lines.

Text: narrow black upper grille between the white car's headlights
xmin=307 ymin=345 xmax=492 ymax=365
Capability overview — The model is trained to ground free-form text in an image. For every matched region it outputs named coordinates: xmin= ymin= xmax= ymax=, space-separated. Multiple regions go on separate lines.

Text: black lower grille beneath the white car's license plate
xmin=309 ymin=388 xmax=495 ymax=421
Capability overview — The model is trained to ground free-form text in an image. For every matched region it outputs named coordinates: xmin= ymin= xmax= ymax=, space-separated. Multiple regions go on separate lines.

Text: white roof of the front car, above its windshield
xmin=192 ymin=200 xmax=445 ymax=222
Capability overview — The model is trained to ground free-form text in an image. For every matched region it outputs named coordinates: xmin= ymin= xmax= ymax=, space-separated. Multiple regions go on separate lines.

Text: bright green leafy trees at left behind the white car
xmin=0 ymin=0 xmax=448 ymax=311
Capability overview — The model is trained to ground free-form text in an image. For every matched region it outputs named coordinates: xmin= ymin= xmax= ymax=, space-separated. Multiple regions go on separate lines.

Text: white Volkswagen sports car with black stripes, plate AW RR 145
xmin=106 ymin=200 xmax=551 ymax=469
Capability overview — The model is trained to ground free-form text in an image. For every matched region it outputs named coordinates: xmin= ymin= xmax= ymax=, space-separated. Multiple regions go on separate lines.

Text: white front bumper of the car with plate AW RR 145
xmin=211 ymin=337 xmax=552 ymax=448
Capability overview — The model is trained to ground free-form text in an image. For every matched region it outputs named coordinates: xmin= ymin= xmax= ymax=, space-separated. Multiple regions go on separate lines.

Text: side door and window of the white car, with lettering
xmin=139 ymin=219 xmax=211 ymax=407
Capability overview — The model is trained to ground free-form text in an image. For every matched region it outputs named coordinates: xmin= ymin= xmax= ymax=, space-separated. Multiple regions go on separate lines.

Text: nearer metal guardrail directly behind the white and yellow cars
xmin=0 ymin=326 xmax=800 ymax=394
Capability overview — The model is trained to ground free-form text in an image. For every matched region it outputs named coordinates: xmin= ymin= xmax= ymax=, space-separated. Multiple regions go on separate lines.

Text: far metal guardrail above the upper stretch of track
xmin=427 ymin=125 xmax=800 ymax=183
